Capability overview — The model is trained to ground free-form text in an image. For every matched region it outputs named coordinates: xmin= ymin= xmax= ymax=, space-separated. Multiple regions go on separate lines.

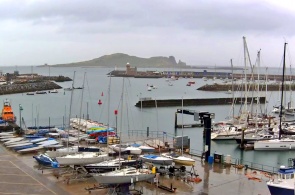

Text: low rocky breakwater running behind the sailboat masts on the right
xmin=197 ymin=83 xmax=295 ymax=91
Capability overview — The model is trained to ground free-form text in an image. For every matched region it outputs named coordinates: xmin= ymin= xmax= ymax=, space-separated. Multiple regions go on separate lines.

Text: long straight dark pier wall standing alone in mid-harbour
xmin=135 ymin=97 xmax=265 ymax=108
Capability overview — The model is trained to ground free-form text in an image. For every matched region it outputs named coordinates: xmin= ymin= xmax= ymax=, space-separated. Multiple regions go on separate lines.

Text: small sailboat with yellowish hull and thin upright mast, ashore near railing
xmin=162 ymin=97 xmax=195 ymax=166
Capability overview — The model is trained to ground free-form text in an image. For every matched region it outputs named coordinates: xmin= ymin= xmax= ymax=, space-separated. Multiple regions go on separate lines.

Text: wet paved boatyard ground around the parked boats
xmin=0 ymin=145 xmax=270 ymax=195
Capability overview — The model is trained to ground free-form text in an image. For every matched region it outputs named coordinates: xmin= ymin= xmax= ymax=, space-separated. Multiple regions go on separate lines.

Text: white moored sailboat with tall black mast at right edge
xmin=254 ymin=43 xmax=295 ymax=150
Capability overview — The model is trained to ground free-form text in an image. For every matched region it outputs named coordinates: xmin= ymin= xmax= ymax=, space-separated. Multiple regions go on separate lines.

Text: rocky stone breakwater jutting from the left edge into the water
xmin=0 ymin=81 xmax=62 ymax=95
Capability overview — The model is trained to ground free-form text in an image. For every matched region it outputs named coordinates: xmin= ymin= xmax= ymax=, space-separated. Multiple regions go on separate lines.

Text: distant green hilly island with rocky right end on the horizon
xmin=50 ymin=53 xmax=186 ymax=68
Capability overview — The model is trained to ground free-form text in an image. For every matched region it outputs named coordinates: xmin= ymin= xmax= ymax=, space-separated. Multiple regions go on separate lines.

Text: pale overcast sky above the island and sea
xmin=0 ymin=0 xmax=295 ymax=67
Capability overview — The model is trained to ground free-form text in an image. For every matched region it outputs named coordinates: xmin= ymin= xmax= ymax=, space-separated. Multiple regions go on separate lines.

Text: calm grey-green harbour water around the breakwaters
xmin=0 ymin=66 xmax=295 ymax=167
